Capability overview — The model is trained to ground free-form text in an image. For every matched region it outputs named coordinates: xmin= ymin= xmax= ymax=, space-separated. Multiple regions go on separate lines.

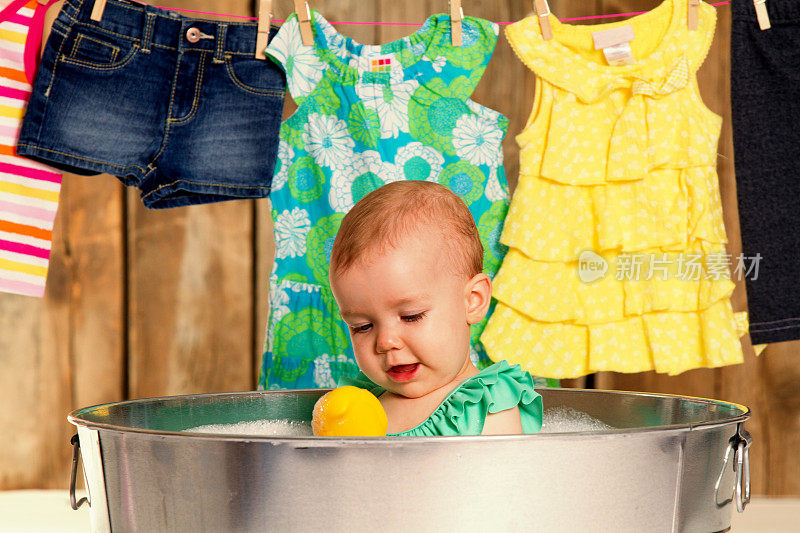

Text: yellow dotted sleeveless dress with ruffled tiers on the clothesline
xmin=481 ymin=0 xmax=742 ymax=378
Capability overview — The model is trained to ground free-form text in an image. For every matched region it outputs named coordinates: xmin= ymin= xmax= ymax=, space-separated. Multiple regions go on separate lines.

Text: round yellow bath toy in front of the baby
xmin=311 ymin=385 xmax=389 ymax=437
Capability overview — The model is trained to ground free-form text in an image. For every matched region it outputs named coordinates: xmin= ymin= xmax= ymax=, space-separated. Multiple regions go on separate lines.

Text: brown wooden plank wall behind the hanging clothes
xmin=0 ymin=0 xmax=800 ymax=495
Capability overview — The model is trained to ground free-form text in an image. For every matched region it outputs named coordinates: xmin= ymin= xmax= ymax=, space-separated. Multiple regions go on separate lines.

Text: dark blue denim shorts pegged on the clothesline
xmin=17 ymin=0 xmax=286 ymax=208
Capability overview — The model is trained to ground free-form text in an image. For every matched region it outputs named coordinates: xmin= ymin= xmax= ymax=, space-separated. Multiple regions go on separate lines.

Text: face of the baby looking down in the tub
xmin=331 ymin=235 xmax=471 ymax=398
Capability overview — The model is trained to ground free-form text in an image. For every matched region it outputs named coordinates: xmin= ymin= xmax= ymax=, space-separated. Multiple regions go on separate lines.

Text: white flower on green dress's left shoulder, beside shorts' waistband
xmin=267 ymin=18 xmax=325 ymax=98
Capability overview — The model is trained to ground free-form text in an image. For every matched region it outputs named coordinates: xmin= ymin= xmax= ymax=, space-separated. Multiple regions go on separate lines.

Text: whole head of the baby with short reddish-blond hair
xmin=330 ymin=181 xmax=492 ymax=398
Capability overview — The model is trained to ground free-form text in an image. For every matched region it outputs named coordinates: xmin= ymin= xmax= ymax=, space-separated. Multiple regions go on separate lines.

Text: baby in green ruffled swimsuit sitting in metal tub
xmin=330 ymin=181 xmax=542 ymax=436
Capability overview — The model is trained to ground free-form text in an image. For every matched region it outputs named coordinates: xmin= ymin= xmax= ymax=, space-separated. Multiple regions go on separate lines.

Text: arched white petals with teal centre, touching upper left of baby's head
xmin=329 ymin=150 xmax=399 ymax=213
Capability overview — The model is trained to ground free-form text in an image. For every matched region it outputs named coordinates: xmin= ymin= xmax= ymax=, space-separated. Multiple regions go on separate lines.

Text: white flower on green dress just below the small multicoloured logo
xmin=355 ymin=78 xmax=419 ymax=139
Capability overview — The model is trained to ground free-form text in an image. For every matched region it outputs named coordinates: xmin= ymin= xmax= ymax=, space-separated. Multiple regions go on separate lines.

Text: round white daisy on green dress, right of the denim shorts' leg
xmin=303 ymin=113 xmax=355 ymax=170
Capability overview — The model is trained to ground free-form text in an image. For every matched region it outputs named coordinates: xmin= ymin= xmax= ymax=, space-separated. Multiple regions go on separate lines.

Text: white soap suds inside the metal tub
xmin=185 ymin=407 xmax=613 ymax=437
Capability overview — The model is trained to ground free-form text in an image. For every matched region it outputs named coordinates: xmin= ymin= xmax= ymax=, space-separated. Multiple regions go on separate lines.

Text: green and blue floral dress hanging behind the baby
xmin=259 ymin=11 xmax=524 ymax=389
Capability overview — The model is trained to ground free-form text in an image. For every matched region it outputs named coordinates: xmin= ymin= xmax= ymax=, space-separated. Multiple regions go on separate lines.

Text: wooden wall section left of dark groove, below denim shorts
xmin=0 ymin=174 xmax=124 ymax=489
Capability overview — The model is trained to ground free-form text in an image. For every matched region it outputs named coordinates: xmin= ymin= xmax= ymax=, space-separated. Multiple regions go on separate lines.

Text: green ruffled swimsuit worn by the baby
xmin=339 ymin=361 xmax=542 ymax=437
